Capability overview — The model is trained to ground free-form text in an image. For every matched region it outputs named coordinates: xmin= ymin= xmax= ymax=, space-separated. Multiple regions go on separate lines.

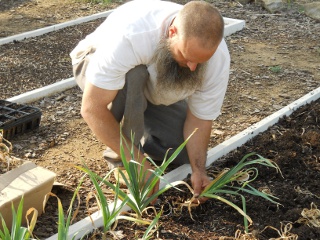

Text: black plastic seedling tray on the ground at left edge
xmin=0 ymin=100 xmax=41 ymax=139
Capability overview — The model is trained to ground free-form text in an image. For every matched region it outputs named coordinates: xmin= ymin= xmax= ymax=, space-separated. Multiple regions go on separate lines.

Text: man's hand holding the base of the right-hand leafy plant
xmin=191 ymin=171 xmax=210 ymax=203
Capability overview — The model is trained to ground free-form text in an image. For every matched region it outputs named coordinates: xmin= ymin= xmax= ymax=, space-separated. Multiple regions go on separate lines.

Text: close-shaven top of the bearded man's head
xmin=174 ymin=1 xmax=224 ymax=48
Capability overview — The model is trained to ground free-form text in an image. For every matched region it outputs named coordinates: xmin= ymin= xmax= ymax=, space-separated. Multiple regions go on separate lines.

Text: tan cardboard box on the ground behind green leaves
xmin=0 ymin=162 xmax=56 ymax=229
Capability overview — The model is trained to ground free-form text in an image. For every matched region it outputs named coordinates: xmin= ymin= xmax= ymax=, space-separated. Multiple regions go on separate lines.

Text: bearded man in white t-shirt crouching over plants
xmin=70 ymin=0 xmax=230 ymax=201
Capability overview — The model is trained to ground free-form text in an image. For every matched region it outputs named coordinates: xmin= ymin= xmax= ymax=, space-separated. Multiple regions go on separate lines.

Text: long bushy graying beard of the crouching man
xmin=152 ymin=39 xmax=207 ymax=91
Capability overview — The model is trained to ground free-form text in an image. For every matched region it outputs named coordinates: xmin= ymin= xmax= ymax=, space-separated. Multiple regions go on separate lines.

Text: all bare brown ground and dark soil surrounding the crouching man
xmin=0 ymin=0 xmax=320 ymax=239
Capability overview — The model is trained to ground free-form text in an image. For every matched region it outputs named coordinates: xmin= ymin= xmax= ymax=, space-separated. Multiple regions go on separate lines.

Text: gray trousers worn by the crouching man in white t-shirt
xmin=73 ymin=55 xmax=189 ymax=165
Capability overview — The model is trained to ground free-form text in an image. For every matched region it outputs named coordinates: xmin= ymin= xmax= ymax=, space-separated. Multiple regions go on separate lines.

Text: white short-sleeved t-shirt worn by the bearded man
xmin=70 ymin=0 xmax=230 ymax=120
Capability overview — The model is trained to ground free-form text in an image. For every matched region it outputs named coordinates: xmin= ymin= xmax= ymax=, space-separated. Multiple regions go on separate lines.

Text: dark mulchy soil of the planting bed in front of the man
xmin=40 ymin=91 xmax=320 ymax=240
